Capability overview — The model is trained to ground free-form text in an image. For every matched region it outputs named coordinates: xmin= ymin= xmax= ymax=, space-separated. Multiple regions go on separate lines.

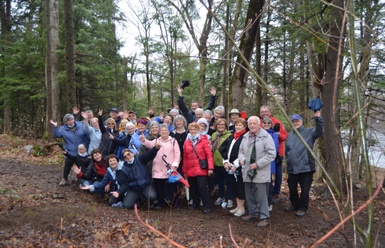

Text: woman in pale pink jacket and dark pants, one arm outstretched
xmin=140 ymin=124 xmax=180 ymax=209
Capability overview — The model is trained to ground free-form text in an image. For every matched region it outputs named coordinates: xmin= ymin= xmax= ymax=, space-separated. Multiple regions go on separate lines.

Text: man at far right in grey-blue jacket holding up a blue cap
xmin=285 ymin=110 xmax=324 ymax=217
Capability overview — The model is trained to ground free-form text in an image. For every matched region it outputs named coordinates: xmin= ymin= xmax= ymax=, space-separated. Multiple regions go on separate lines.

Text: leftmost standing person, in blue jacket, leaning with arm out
xmin=50 ymin=114 xmax=86 ymax=186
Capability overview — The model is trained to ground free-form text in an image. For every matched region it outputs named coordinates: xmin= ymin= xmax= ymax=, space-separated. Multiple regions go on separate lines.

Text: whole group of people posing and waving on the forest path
xmin=51 ymin=86 xmax=323 ymax=227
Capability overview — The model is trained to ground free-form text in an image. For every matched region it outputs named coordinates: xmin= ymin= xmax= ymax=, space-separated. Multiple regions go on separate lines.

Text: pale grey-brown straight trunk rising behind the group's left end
xmin=45 ymin=0 xmax=61 ymax=140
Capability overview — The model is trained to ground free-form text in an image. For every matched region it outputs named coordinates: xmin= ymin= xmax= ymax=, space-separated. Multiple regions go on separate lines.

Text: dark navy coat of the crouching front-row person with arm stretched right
xmin=116 ymin=147 xmax=158 ymax=195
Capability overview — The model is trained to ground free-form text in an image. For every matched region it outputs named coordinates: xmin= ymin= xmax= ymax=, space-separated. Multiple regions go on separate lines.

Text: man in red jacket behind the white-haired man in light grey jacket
xmin=259 ymin=105 xmax=287 ymax=203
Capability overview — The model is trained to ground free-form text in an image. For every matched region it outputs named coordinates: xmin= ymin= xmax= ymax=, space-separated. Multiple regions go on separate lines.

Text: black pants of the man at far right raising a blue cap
xmin=287 ymin=172 xmax=314 ymax=211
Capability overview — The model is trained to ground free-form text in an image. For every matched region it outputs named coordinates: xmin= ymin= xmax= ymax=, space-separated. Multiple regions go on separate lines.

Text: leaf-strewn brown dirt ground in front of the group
xmin=0 ymin=135 xmax=385 ymax=247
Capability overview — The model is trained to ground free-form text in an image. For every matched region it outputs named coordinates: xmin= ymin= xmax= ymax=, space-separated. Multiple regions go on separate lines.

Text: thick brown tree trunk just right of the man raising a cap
xmin=322 ymin=0 xmax=346 ymax=192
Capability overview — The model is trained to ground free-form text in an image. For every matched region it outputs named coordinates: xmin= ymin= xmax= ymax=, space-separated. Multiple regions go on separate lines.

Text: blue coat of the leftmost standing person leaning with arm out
xmin=53 ymin=121 xmax=87 ymax=156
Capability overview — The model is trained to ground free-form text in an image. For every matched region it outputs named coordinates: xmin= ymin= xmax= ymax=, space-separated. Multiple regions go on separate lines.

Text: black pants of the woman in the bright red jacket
xmin=188 ymin=176 xmax=210 ymax=209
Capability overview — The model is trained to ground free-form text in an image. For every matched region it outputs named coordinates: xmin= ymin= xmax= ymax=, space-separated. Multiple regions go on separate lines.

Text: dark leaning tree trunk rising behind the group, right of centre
xmin=231 ymin=0 xmax=264 ymax=109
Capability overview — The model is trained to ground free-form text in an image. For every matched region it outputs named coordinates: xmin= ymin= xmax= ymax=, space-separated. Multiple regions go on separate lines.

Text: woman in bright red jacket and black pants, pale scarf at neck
xmin=182 ymin=123 xmax=214 ymax=214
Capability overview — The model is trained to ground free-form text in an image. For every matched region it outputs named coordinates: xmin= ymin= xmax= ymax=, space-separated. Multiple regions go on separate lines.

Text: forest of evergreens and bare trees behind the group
xmin=0 ymin=0 xmax=385 ymax=247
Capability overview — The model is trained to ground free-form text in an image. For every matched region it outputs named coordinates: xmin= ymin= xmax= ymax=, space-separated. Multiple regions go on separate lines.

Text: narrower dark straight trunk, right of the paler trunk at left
xmin=64 ymin=0 xmax=77 ymax=108
